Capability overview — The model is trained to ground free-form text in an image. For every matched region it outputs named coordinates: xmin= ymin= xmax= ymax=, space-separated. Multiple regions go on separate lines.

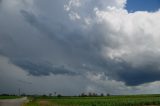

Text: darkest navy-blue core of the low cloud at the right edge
xmin=117 ymin=61 xmax=160 ymax=86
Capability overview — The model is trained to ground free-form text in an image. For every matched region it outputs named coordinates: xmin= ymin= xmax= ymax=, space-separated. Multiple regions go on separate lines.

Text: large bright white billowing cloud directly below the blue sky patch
xmin=89 ymin=8 xmax=160 ymax=65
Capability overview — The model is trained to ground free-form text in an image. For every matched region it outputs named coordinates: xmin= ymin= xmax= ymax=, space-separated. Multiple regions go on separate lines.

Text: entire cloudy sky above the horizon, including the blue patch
xmin=0 ymin=0 xmax=160 ymax=95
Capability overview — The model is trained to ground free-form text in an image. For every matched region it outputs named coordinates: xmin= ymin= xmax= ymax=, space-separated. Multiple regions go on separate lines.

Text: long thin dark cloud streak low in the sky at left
xmin=12 ymin=60 xmax=76 ymax=76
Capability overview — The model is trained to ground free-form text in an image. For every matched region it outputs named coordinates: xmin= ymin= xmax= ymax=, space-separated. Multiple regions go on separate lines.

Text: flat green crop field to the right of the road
xmin=24 ymin=95 xmax=160 ymax=106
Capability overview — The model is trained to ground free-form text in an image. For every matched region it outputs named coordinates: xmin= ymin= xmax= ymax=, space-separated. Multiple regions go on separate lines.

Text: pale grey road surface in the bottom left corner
xmin=0 ymin=97 xmax=27 ymax=106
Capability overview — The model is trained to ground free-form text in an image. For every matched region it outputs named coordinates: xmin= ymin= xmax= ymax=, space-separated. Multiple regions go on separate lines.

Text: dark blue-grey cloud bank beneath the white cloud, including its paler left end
xmin=102 ymin=61 xmax=160 ymax=86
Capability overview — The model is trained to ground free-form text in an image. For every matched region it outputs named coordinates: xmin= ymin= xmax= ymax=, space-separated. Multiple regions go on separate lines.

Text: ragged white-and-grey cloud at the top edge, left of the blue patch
xmin=64 ymin=0 xmax=126 ymax=21
